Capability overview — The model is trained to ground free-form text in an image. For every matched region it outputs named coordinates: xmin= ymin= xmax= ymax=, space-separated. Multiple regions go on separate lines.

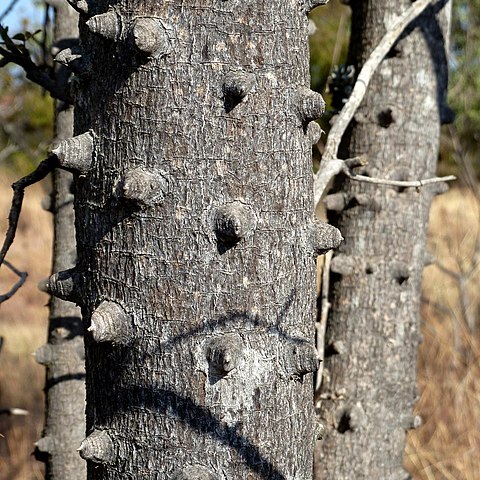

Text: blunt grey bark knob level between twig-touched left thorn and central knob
xmin=121 ymin=167 xmax=168 ymax=207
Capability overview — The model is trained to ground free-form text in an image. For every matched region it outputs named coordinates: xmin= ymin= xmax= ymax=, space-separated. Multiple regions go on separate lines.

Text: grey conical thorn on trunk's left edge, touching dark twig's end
xmin=51 ymin=132 xmax=93 ymax=175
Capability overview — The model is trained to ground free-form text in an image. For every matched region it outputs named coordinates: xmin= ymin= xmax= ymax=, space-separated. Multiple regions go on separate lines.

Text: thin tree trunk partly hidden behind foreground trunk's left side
xmin=35 ymin=2 xmax=86 ymax=480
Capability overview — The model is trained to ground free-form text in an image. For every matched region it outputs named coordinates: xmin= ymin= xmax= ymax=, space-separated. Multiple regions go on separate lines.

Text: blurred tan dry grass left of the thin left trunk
xmin=0 ymin=178 xmax=52 ymax=480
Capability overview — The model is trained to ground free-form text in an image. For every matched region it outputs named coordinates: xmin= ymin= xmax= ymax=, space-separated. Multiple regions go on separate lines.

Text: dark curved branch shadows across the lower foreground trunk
xmin=87 ymin=289 xmax=316 ymax=480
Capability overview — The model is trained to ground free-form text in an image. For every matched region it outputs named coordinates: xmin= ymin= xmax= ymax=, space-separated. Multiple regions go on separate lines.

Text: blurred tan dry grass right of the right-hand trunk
xmin=406 ymin=190 xmax=480 ymax=480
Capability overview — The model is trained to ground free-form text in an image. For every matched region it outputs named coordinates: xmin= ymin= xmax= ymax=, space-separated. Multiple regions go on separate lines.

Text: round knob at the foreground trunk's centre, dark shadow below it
xmin=213 ymin=202 xmax=255 ymax=244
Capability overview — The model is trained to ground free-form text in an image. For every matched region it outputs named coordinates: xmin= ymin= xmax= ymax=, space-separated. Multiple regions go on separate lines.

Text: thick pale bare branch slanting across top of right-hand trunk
xmin=314 ymin=0 xmax=432 ymax=205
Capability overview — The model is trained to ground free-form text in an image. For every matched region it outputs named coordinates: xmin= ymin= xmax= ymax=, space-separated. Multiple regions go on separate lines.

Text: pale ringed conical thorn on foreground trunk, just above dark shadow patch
xmin=88 ymin=301 xmax=132 ymax=345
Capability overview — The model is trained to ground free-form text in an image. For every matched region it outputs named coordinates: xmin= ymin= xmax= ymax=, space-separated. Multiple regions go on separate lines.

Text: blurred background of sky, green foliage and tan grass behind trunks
xmin=0 ymin=0 xmax=480 ymax=480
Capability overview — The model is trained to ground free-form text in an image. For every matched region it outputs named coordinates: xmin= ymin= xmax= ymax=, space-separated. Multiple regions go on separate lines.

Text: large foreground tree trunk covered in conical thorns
xmin=46 ymin=0 xmax=341 ymax=480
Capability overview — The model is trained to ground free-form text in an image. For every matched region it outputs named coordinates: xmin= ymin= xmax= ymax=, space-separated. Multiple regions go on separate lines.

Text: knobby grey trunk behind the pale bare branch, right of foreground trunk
xmin=316 ymin=0 xmax=449 ymax=480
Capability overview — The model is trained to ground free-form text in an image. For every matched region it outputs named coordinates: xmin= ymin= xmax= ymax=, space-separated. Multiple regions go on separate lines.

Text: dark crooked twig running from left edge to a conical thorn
xmin=0 ymin=155 xmax=58 ymax=272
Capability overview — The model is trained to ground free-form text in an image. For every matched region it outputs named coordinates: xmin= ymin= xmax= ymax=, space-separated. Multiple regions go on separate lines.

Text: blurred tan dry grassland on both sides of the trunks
xmin=0 ymin=172 xmax=480 ymax=480
